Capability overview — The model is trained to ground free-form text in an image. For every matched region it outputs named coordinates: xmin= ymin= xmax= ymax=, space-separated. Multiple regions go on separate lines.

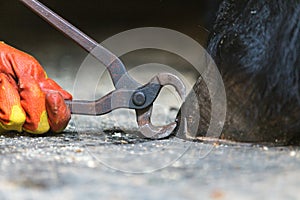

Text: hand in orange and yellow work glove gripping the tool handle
xmin=0 ymin=42 xmax=72 ymax=134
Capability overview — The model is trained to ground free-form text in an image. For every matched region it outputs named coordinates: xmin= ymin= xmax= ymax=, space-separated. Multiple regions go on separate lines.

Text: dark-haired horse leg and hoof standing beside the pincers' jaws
xmin=179 ymin=0 xmax=300 ymax=144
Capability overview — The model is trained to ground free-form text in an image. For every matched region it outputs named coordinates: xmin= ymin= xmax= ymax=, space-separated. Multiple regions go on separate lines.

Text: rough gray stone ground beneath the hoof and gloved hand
xmin=0 ymin=127 xmax=300 ymax=199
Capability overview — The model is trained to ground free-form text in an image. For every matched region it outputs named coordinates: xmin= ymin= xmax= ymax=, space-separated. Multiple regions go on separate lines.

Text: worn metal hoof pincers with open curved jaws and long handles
xmin=20 ymin=0 xmax=186 ymax=139
